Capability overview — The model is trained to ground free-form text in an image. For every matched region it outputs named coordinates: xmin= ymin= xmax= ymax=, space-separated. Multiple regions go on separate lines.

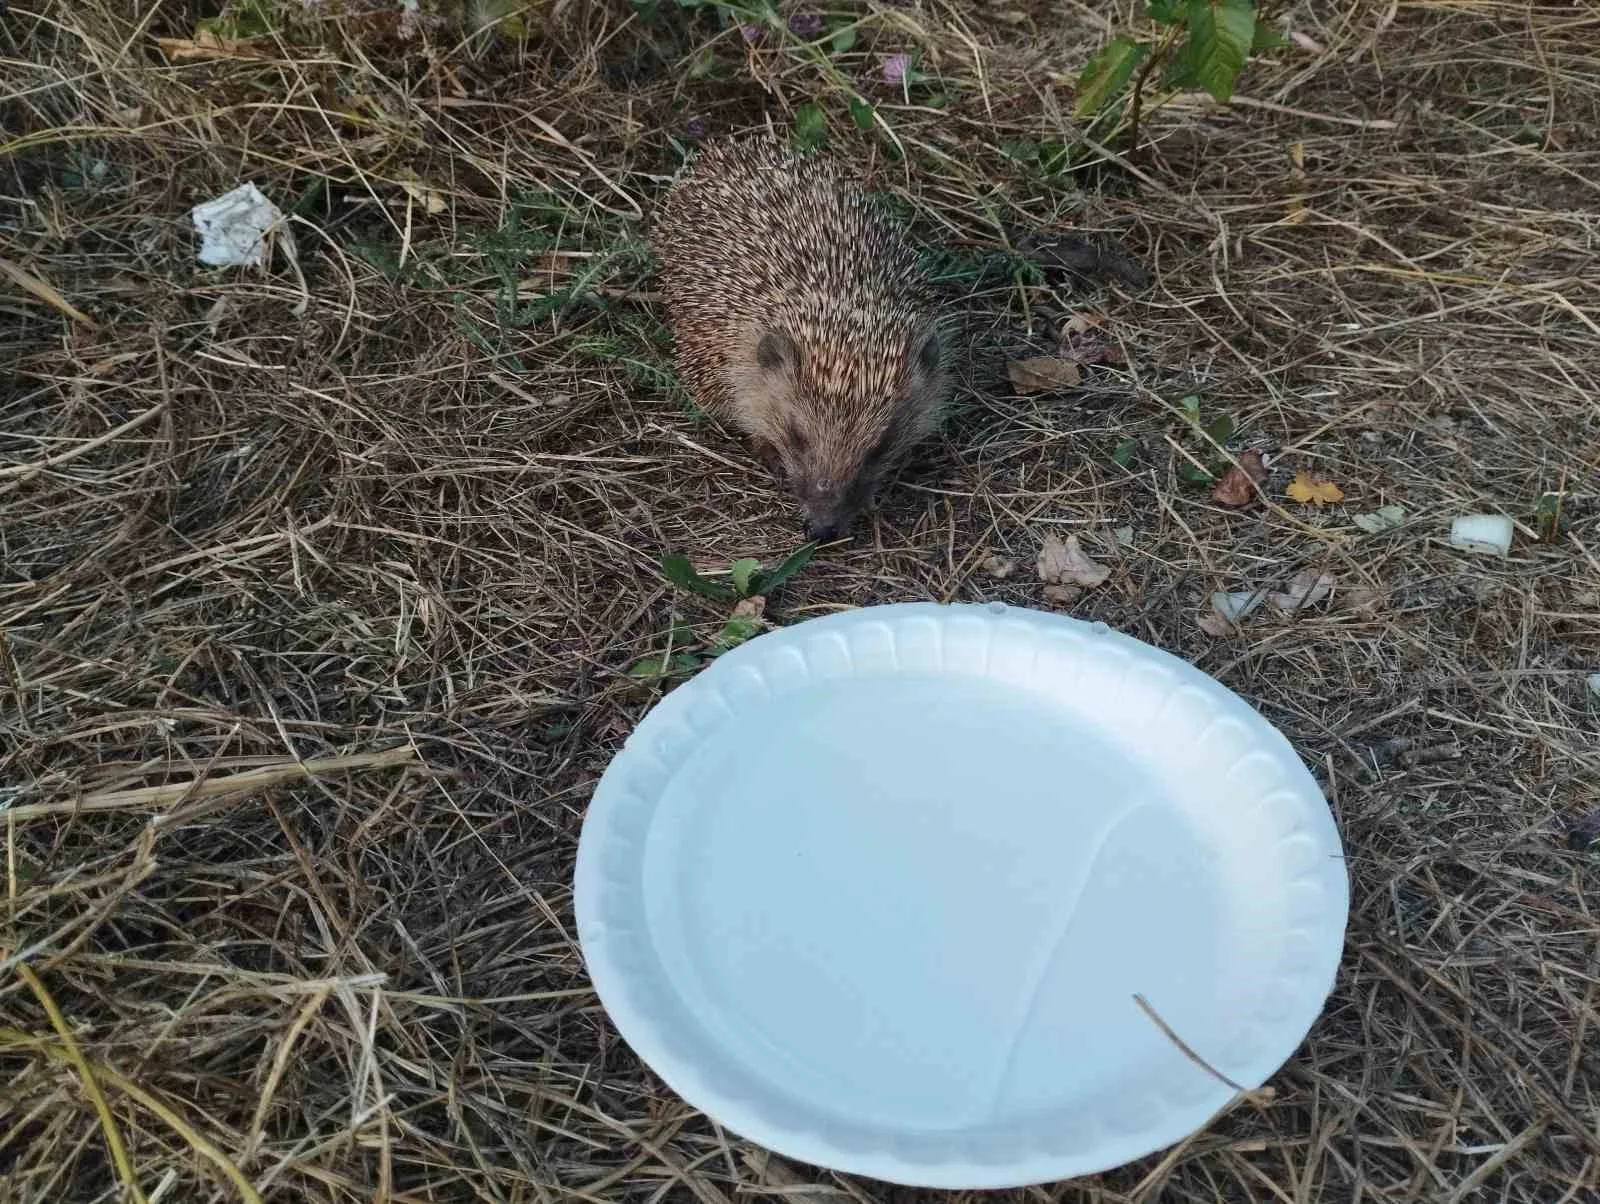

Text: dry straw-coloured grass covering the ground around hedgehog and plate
xmin=0 ymin=0 xmax=1600 ymax=1204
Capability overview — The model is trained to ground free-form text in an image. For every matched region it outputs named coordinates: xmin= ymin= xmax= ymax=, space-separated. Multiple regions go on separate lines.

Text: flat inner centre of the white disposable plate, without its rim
xmin=643 ymin=672 xmax=1228 ymax=1132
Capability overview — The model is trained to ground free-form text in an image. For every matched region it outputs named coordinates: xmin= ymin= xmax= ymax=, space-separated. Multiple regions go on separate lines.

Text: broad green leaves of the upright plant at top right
xmin=1074 ymin=0 xmax=1285 ymax=147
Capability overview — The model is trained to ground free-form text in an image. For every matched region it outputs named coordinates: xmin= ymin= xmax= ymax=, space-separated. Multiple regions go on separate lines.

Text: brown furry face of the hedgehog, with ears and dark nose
xmin=728 ymin=322 xmax=950 ymax=540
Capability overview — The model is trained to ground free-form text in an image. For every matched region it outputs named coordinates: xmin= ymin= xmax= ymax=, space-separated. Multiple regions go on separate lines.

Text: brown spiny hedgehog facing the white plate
xmin=651 ymin=134 xmax=950 ymax=541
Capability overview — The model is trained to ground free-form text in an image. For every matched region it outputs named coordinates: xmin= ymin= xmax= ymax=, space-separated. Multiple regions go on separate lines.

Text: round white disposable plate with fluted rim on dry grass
xmin=574 ymin=604 xmax=1349 ymax=1188
